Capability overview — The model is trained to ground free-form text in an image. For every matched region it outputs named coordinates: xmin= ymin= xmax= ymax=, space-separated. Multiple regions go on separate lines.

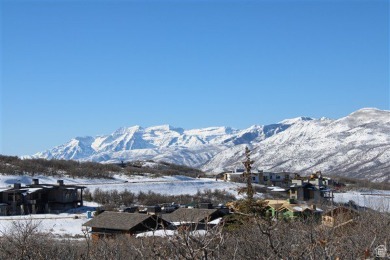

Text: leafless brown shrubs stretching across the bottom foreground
xmin=0 ymin=207 xmax=390 ymax=259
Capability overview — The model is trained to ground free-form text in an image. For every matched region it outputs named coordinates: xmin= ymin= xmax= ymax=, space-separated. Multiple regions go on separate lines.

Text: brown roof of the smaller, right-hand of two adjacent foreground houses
xmin=163 ymin=208 xmax=219 ymax=223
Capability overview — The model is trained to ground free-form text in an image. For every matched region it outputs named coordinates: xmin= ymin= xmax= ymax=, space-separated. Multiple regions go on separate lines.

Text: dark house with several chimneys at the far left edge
xmin=0 ymin=179 xmax=85 ymax=215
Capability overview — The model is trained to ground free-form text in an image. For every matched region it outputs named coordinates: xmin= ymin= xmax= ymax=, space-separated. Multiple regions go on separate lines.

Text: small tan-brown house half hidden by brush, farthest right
xmin=322 ymin=206 xmax=359 ymax=228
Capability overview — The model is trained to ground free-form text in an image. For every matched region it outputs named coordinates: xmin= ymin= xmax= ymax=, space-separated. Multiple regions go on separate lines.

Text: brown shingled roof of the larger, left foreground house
xmin=83 ymin=211 xmax=152 ymax=231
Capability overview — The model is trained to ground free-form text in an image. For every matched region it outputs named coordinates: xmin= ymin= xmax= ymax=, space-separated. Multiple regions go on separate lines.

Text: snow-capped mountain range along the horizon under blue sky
xmin=32 ymin=108 xmax=390 ymax=181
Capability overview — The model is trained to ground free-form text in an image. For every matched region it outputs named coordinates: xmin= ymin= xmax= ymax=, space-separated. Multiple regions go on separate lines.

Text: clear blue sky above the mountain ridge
xmin=0 ymin=0 xmax=390 ymax=155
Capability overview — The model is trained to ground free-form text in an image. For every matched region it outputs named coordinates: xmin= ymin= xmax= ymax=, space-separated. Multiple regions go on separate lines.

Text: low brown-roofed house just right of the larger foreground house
xmin=162 ymin=208 xmax=225 ymax=230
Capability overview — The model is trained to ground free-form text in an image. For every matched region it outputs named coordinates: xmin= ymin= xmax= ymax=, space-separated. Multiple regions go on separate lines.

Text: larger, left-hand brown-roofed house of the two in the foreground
xmin=83 ymin=211 xmax=169 ymax=241
